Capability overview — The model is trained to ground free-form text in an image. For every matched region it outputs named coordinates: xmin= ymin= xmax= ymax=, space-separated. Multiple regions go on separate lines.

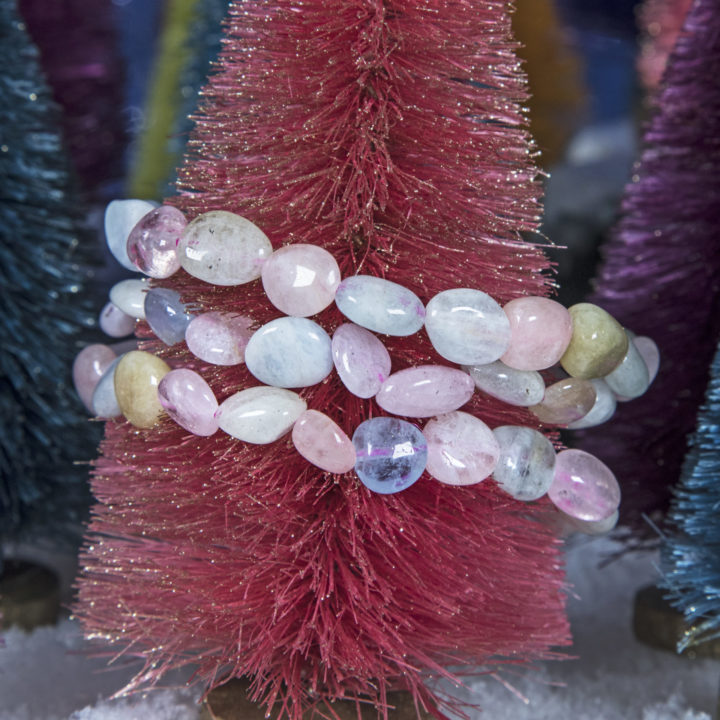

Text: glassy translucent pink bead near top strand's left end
xmin=127 ymin=205 xmax=187 ymax=278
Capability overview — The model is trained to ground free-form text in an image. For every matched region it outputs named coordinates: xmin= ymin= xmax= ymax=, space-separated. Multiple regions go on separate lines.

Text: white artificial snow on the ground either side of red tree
xmin=0 ymin=539 xmax=720 ymax=720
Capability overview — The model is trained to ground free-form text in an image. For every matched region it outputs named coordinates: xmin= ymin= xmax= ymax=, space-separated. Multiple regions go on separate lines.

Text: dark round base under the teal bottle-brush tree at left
xmin=0 ymin=560 xmax=60 ymax=631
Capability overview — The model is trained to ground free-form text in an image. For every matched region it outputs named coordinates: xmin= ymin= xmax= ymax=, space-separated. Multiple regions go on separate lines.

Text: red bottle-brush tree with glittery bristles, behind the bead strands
xmin=78 ymin=0 xmax=568 ymax=720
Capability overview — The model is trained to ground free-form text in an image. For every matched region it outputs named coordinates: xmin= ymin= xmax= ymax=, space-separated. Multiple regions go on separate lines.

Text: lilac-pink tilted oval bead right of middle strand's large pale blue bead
xmin=332 ymin=323 xmax=391 ymax=398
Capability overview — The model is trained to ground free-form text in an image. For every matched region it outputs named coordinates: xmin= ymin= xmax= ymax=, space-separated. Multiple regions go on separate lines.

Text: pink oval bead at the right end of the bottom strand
xmin=548 ymin=450 xmax=620 ymax=521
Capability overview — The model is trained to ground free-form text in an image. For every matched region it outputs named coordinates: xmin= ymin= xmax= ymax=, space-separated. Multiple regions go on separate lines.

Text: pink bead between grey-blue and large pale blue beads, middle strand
xmin=185 ymin=312 xmax=253 ymax=365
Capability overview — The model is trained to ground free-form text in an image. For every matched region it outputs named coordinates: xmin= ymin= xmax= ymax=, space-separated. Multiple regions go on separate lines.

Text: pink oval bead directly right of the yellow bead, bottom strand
xmin=158 ymin=368 xmax=218 ymax=437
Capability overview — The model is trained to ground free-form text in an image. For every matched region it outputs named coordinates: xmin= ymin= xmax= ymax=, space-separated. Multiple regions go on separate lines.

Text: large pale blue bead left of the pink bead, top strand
xmin=425 ymin=288 xmax=510 ymax=365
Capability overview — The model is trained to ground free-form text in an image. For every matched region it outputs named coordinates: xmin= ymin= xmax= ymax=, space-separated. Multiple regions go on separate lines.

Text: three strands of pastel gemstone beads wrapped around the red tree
xmin=74 ymin=200 xmax=659 ymax=529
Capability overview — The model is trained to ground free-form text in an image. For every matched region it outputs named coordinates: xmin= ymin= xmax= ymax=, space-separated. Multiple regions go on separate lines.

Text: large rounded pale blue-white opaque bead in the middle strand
xmin=245 ymin=317 xmax=333 ymax=388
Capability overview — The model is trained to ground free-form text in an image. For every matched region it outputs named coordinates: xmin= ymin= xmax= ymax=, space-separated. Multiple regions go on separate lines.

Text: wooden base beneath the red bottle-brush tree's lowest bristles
xmin=200 ymin=678 xmax=433 ymax=720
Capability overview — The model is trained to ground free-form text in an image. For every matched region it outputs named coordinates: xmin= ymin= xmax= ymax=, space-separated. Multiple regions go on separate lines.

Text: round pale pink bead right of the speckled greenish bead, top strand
xmin=262 ymin=244 xmax=340 ymax=317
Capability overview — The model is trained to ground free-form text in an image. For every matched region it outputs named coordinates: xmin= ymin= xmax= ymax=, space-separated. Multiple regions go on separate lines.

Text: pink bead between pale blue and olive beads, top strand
xmin=500 ymin=296 xmax=572 ymax=370
